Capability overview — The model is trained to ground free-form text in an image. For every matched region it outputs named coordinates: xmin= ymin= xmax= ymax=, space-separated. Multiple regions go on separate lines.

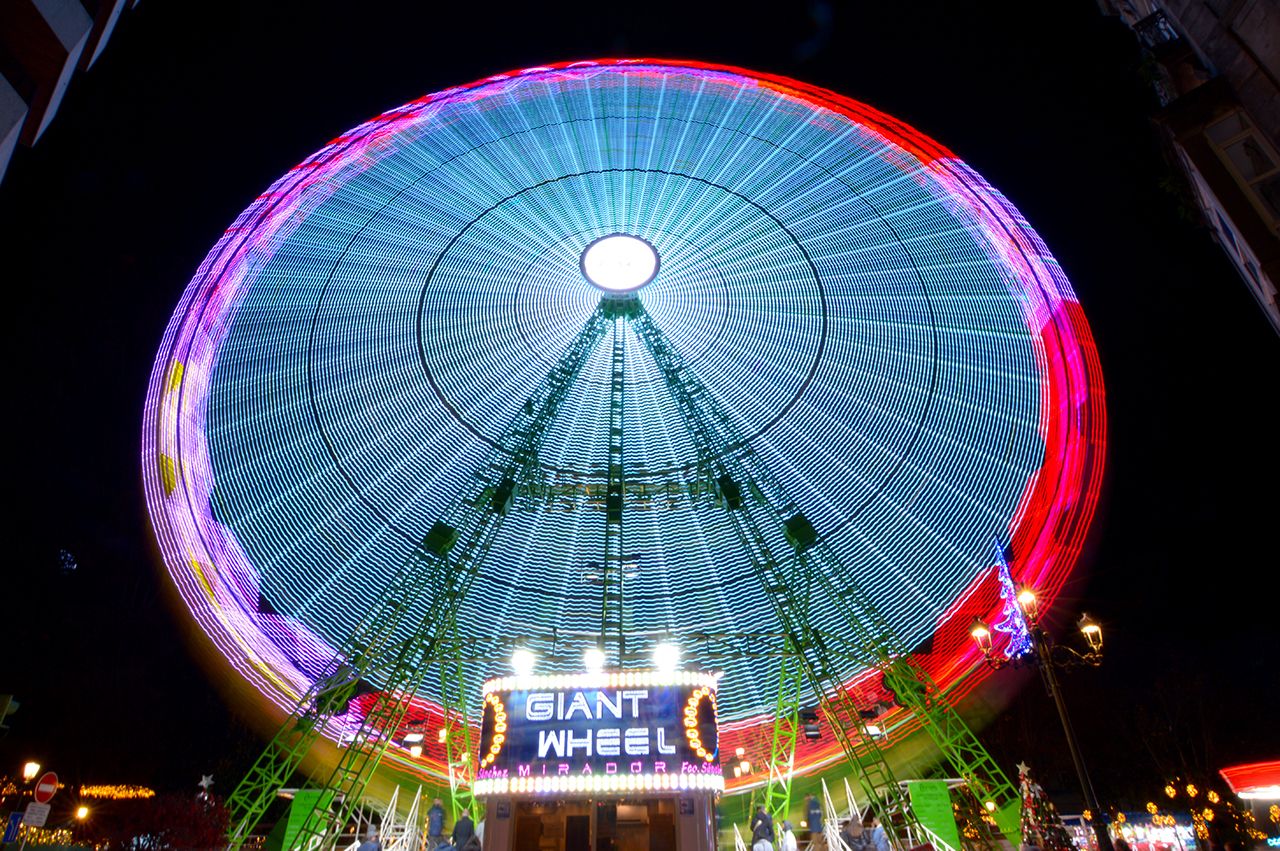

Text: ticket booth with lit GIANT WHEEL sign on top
xmin=475 ymin=671 xmax=724 ymax=851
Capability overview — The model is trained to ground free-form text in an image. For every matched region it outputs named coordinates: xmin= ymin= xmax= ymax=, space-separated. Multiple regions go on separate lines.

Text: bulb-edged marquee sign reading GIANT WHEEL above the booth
xmin=475 ymin=671 xmax=724 ymax=795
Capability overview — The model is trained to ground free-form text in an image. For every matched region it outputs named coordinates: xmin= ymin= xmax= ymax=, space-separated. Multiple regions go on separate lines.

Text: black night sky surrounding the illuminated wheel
xmin=0 ymin=0 xmax=1280 ymax=810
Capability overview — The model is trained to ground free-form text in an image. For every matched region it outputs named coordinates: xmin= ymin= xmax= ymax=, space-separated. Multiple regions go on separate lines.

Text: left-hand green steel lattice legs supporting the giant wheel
xmin=227 ymin=305 xmax=611 ymax=851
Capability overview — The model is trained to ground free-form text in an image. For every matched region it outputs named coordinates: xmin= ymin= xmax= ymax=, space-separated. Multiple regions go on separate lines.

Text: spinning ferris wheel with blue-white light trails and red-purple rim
xmin=142 ymin=60 xmax=1103 ymax=844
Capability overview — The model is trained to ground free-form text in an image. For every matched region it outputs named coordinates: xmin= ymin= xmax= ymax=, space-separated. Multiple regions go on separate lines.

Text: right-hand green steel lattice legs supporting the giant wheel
xmin=630 ymin=302 xmax=1019 ymax=846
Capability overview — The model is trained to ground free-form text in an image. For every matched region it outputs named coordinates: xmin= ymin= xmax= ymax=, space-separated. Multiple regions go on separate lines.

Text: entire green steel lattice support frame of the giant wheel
xmin=228 ymin=290 xmax=1019 ymax=850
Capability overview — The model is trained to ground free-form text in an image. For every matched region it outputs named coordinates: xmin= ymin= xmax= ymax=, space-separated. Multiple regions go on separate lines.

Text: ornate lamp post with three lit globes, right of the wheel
xmin=969 ymin=586 xmax=1115 ymax=851
